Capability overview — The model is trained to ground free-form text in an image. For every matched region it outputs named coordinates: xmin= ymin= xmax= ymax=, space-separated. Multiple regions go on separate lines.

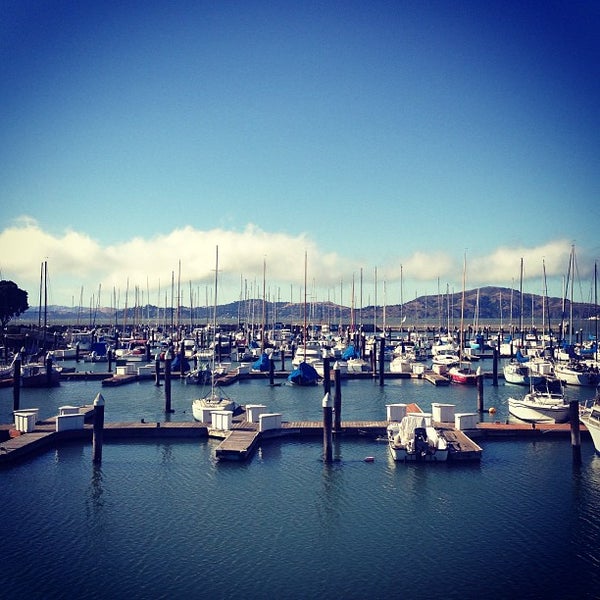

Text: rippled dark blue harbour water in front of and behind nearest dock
xmin=0 ymin=366 xmax=600 ymax=599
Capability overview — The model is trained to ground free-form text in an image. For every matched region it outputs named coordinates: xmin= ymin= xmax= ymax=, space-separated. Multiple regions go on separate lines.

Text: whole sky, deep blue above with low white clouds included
xmin=0 ymin=0 xmax=600 ymax=306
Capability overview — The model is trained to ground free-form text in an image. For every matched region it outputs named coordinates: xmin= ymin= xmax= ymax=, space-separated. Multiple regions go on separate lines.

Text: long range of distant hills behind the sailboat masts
xmin=12 ymin=286 xmax=599 ymax=327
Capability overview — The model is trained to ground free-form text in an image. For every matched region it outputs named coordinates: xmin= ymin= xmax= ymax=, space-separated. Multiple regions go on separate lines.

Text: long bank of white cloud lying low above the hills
xmin=0 ymin=217 xmax=593 ymax=306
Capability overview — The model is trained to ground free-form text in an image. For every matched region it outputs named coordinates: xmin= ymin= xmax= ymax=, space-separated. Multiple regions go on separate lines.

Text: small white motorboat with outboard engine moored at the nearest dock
xmin=387 ymin=413 xmax=448 ymax=462
